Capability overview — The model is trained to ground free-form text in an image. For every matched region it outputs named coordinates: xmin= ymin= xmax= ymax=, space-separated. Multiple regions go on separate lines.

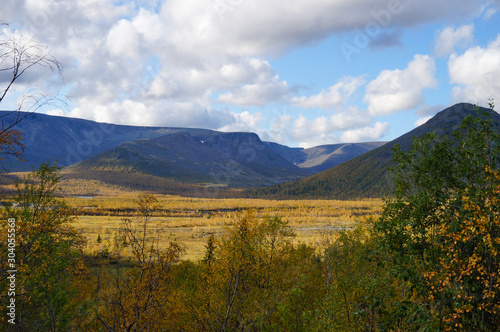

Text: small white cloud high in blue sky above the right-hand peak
xmin=434 ymin=24 xmax=474 ymax=56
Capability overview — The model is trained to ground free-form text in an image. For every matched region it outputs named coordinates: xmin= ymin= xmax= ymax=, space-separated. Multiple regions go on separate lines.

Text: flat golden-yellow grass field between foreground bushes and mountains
xmin=67 ymin=194 xmax=383 ymax=260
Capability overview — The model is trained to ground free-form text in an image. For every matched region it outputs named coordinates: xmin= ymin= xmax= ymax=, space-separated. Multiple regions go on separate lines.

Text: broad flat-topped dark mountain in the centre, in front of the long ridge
xmin=68 ymin=132 xmax=311 ymax=187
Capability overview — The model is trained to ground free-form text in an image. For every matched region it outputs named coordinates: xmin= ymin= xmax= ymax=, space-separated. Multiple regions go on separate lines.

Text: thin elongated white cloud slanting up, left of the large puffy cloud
xmin=291 ymin=77 xmax=365 ymax=110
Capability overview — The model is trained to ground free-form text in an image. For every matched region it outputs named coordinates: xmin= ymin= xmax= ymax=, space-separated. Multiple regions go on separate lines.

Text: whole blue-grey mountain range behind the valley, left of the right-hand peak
xmin=0 ymin=112 xmax=382 ymax=191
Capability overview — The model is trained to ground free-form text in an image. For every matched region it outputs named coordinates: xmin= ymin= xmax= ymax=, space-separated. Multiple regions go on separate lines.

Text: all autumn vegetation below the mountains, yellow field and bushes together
xmin=0 ymin=105 xmax=500 ymax=331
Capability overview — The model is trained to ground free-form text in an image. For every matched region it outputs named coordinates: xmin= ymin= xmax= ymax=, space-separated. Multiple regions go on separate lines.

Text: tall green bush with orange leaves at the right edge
xmin=375 ymin=104 xmax=500 ymax=331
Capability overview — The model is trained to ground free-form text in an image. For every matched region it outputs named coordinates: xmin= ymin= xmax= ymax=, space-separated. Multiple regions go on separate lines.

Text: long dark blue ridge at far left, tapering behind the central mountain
xmin=0 ymin=112 xmax=219 ymax=171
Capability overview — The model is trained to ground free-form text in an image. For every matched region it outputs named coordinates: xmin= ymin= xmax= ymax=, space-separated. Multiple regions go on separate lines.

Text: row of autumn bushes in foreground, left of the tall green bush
xmin=0 ymin=164 xmax=393 ymax=331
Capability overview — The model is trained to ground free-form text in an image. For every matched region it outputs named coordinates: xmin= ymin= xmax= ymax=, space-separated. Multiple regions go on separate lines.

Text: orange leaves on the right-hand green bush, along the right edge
xmin=424 ymin=183 xmax=500 ymax=327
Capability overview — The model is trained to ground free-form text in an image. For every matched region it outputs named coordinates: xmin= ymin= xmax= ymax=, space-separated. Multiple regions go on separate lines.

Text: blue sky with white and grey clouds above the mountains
xmin=0 ymin=0 xmax=500 ymax=147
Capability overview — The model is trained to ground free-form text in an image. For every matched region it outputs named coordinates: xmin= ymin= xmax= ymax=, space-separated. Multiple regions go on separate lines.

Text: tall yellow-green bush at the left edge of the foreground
xmin=0 ymin=162 xmax=86 ymax=331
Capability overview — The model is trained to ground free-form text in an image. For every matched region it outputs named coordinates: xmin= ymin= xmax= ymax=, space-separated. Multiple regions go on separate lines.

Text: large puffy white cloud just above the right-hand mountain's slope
xmin=364 ymin=54 xmax=436 ymax=116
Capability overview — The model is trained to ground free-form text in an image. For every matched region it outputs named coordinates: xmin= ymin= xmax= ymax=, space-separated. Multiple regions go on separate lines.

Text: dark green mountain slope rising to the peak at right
xmin=246 ymin=103 xmax=500 ymax=199
